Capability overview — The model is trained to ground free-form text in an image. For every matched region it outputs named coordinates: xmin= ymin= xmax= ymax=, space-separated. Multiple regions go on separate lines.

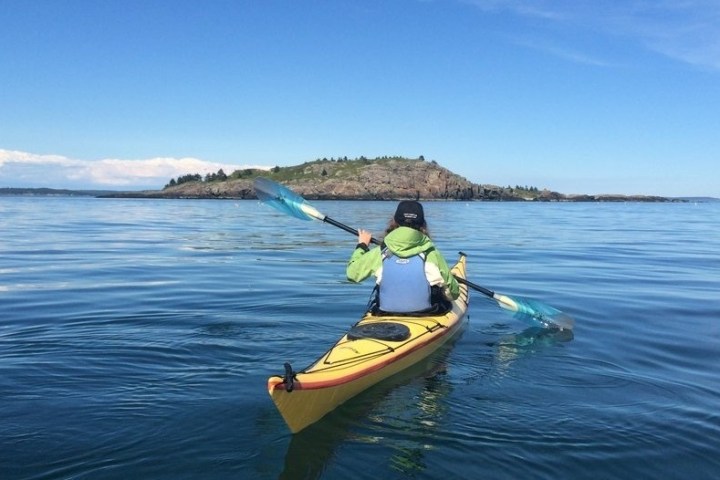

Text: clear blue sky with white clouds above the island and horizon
xmin=0 ymin=0 xmax=720 ymax=197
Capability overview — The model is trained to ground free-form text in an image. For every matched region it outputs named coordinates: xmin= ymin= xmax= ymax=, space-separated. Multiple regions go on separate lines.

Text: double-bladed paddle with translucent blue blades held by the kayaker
xmin=254 ymin=177 xmax=575 ymax=329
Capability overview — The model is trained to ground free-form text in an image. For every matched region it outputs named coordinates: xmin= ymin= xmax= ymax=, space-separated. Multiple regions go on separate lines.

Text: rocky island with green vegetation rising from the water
xmin=103 ymin=157 xmax=672 ymax=202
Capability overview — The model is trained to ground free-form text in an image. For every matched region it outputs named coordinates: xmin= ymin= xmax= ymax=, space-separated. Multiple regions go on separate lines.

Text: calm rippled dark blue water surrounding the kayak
xmin=0 ymin=197 xmax=720 ymax=479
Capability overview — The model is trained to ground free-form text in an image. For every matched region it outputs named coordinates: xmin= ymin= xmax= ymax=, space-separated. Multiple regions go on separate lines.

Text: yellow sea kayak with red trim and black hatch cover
xmin=268 ymin=254 xmax=469 ymax=433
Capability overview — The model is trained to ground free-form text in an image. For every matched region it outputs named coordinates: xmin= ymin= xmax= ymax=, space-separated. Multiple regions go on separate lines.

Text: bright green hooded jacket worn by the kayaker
xmin=347 ymin=227 xmax=460 ymax=299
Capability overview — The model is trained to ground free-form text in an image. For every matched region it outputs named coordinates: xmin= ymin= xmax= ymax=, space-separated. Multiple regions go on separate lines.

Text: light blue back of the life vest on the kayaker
xmin=378 ymin=251 xmax=432 ymax=313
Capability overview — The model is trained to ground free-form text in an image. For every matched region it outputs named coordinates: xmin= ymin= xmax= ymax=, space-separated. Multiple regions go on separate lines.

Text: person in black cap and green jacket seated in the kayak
xmin=347 ymin=200 xmax=460 ymax=313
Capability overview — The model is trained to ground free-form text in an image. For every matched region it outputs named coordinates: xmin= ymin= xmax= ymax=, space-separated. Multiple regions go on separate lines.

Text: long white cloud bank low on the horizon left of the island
xmin=0 ymin=149 xmax=270 ymax=189
